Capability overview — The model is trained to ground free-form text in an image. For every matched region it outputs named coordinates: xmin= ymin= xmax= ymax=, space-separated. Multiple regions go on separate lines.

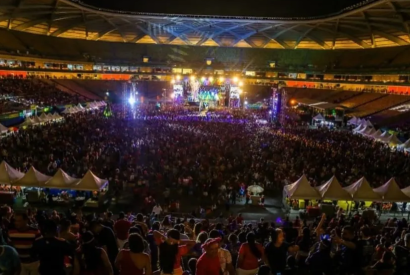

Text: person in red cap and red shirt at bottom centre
xmin=196 ymin=238 xmax=222 ymax=275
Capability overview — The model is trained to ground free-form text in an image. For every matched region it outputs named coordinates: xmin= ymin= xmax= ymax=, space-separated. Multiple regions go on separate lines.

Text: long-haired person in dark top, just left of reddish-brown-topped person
xmin=74 ymin=231 xmax=114 ymax=275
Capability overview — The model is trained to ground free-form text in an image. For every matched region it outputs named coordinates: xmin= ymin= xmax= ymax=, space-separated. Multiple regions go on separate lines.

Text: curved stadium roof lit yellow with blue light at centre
xmin=0 ymin=0 xmax=410 ymax=49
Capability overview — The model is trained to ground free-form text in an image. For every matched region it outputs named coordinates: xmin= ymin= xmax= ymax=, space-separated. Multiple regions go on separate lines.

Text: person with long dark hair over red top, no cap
xmin=236 ymin=232 xmax=265 ymax=275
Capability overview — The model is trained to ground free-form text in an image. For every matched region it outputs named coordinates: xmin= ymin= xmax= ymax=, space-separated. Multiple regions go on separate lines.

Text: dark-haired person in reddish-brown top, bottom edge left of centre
xmin=115 ymin=233 xmax=152 ymax=275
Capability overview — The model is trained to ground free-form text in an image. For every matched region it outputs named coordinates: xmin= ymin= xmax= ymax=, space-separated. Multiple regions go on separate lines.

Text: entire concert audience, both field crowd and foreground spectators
xmin=0 ymin=93 xmax=410 ymax=275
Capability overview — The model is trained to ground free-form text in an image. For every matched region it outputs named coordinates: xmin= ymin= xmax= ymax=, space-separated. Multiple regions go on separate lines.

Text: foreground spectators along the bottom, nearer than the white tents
xmin=0 ymin=201 xmax=410 ymax=275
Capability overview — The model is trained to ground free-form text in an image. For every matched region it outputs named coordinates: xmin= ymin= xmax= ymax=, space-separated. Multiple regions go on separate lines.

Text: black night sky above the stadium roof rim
xmin=82 ymin=0 xmax=361 ymax=17
